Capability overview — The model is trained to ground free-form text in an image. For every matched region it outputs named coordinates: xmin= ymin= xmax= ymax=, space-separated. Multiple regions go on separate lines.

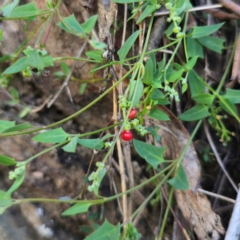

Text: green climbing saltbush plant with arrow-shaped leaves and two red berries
xmin=0 ymin=0 xmax=240 ymax=240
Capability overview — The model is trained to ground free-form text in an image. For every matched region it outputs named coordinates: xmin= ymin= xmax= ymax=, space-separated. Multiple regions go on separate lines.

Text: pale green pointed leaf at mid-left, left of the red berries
xmin=32 ymin=127 xmax=68 ymax=143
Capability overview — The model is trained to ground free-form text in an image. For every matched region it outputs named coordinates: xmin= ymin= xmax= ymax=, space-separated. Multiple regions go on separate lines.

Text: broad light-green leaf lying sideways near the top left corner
xmin=10 ymin=2 xmax=40 ymax=18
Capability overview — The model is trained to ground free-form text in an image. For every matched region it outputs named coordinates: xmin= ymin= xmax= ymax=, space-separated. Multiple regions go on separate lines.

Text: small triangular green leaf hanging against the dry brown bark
xmin=168 ymin=164 xmax=189 ymax=190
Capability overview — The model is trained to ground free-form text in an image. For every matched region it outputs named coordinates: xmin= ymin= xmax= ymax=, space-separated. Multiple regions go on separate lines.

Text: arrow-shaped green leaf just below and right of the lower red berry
xmin=133 ymin=139 xmax=165 ymax=169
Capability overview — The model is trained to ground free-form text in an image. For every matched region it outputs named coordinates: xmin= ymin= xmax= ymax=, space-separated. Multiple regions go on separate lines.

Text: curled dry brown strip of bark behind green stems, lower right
xmin=146 ymin=107 xmax=224 ymax=239
